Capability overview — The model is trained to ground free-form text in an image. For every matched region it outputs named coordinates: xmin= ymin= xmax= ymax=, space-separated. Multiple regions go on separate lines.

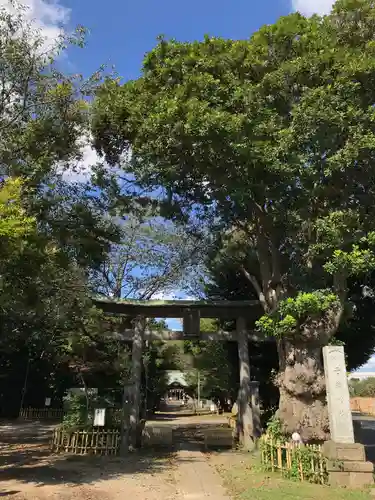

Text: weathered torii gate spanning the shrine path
xmin=93 ymin=297 xmax=267 ymax=450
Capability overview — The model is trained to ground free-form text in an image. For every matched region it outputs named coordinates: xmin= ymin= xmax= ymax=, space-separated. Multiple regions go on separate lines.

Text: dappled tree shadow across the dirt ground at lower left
xmin=0 ymin=422 xmax=210 ymax=488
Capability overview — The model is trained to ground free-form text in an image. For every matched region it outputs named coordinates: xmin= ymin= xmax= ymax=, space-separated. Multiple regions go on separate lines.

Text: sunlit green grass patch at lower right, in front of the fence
xmin=210 ymin=453 xmax=374 ymax=500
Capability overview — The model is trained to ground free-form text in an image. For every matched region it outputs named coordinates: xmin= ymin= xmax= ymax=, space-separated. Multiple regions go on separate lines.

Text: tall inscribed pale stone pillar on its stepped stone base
xmin=323 ymin=345 xmax=374 ymax=487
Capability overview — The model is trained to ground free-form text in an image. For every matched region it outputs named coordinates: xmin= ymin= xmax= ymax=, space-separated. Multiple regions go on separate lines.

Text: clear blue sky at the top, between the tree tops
xmin=62 ymin=0 xmax=292 ymax=79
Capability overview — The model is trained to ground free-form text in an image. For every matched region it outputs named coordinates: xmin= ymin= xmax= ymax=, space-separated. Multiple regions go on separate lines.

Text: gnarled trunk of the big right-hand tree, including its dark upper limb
xmin=242 ymin=213 xmax=346 ymax=442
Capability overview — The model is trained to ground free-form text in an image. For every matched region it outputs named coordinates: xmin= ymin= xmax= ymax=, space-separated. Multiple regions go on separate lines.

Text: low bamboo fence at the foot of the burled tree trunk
xmin=260 ymin=436 xmax=327 ymax=484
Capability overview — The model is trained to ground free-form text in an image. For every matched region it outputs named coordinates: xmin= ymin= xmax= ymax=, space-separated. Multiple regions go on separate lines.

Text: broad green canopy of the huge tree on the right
xmin=93 ymin=0 xmax=374 ymax=329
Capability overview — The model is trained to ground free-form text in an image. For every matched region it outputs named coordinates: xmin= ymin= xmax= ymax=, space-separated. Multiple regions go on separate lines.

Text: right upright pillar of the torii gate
xmin=237 ymin=318 xmax=255 ymax=451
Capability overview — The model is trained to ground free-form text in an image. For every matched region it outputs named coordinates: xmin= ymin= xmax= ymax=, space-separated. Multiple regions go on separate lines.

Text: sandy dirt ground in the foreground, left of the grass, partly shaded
xmin=0 ymin=423 xmax=230 ymax=500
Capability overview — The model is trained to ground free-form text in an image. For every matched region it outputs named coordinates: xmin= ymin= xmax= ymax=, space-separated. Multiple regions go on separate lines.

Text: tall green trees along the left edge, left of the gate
xmin=0 ymin=1 xmax=120 ymax=409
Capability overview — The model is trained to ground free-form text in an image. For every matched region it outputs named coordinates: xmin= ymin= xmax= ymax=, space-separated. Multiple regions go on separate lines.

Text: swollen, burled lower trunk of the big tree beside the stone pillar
xmin=277 ymin=336 xmax=329 ymax=442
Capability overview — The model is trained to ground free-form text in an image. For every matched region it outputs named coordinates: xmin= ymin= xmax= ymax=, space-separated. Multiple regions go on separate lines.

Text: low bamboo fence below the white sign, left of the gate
xmin=51 ymin=429 xmax=121 ymax=455
